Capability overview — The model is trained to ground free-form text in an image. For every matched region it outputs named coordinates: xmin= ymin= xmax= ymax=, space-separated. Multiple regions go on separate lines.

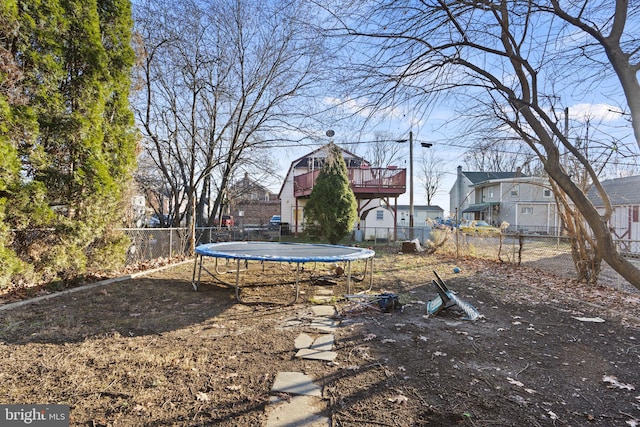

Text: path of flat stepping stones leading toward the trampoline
xmin=265 ymin=289 xmax=339 ymax=427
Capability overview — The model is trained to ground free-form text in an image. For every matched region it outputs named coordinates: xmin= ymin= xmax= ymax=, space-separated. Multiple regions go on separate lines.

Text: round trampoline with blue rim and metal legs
xmin=191 ymin=242 xmax=375 ymax=304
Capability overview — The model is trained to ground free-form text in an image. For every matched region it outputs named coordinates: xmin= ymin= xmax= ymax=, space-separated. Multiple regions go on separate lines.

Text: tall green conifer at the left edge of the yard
xmin=0 ymin=0 xmax=136 ymax=288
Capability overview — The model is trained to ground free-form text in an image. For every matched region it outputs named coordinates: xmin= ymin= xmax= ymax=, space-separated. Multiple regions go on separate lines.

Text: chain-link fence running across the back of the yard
xmin=6 ymin=227 xmax=640 ymax=290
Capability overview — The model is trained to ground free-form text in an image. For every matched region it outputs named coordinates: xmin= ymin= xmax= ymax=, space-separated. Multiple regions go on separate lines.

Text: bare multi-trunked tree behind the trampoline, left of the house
xmin=134 ymin=0 xmax=324 ymax=236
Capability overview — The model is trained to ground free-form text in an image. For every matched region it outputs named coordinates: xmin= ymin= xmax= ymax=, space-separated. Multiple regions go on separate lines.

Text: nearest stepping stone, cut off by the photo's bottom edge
xmin=265 ymin=396 xmax=331 ymax=427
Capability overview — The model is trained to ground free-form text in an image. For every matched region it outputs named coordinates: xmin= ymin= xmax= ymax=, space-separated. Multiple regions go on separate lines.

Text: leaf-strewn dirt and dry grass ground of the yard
xmin=0 ymin=251 xmax=640 ymax=426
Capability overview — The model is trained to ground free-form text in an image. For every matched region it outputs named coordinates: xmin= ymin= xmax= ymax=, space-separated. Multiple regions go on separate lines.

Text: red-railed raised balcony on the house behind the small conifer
xmin=293 ymin=166 xmax=407 ymax=199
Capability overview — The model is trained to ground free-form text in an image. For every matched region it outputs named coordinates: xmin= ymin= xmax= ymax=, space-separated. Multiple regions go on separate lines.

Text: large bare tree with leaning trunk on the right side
xmin=334 ymin=0 xmax=640 ymax=288
